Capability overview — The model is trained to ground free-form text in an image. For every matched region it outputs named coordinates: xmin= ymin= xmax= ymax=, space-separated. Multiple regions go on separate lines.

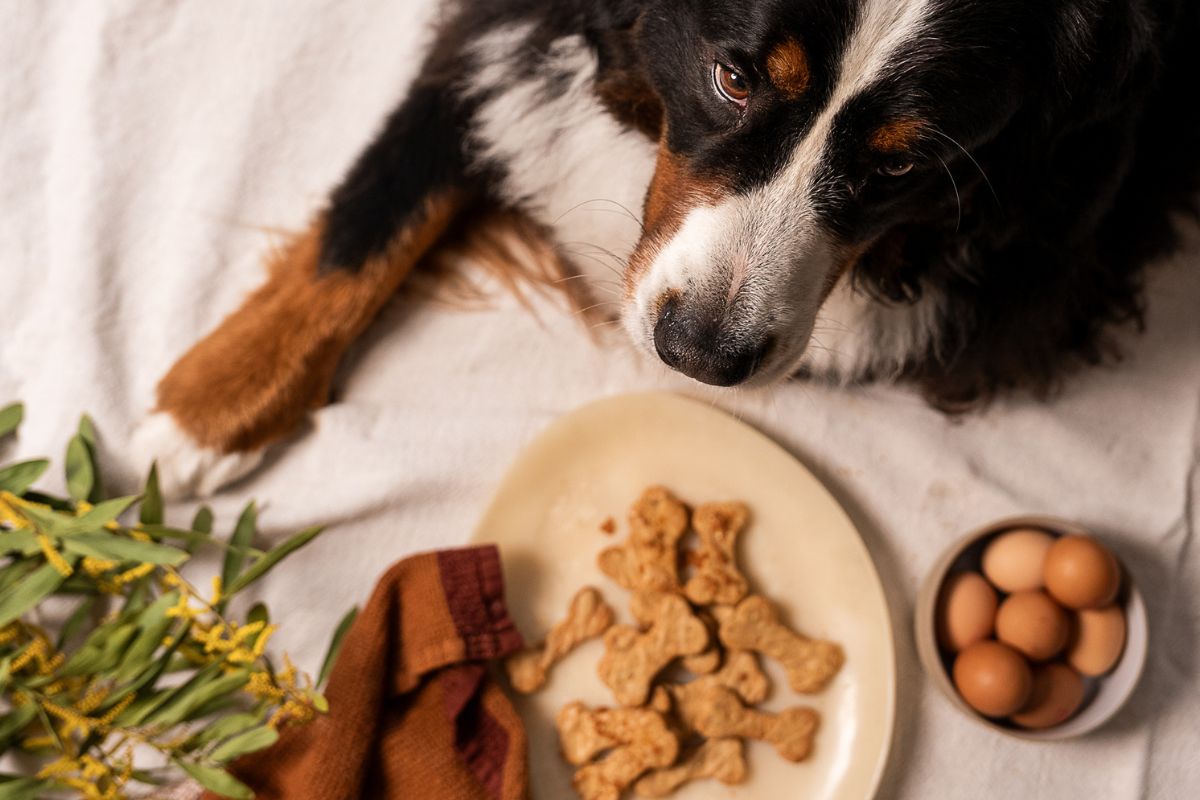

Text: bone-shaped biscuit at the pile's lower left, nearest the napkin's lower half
xmin=554 ymin=702 xmax=679 ymax=766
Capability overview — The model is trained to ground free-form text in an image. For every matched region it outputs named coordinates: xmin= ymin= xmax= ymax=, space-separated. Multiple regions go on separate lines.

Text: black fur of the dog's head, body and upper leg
xmin=323 ymin=0 xmax=1200 ymax=409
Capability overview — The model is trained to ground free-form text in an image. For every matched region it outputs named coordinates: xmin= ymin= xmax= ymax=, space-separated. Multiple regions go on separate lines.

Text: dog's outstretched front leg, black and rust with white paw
xmin=136 ymin=80 xmax=473 ymax=497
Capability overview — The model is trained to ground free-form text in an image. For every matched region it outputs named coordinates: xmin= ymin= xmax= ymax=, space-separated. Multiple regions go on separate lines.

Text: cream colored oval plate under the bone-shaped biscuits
xmin=475 ymin=395 xmax=895 ymax=800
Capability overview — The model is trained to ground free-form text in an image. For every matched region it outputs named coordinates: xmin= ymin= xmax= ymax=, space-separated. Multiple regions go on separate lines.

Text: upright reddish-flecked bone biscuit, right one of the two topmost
xmin=684 ymin=503 xmax=750 ymax=606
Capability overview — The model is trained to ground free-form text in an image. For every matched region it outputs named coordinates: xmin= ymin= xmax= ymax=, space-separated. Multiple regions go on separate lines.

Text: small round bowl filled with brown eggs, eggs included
xmin=916 ymin=517 xmax=1147 ymax=740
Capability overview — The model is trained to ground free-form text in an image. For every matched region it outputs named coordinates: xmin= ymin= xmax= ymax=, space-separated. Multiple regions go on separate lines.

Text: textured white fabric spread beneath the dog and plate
xmin=0 ymin=0 xmax=1200 ymax=800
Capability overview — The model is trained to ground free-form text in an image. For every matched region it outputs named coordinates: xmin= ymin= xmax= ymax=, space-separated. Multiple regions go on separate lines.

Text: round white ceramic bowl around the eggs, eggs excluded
xmin=916 ymin=516 xmax=1148 ymax=741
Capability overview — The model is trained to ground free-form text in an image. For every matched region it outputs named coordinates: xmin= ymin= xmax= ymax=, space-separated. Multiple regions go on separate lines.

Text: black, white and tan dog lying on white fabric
xmin=131 ymin=0 xmax=1200 ymax=494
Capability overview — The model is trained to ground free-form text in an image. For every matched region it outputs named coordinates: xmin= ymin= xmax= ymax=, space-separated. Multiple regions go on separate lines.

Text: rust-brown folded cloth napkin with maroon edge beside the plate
xmin=204 ymin=546 xmax=529 ymax=800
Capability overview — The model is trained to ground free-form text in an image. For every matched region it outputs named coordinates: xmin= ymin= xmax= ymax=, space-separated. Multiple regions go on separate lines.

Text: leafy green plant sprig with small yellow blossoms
xmin=0 ymin=404 xmax=353 ymax=800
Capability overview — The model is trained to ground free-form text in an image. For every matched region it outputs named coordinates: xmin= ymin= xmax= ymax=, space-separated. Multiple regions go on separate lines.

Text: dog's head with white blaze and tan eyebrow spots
xmin=624 ymin=0 xmax=1055 ymax=385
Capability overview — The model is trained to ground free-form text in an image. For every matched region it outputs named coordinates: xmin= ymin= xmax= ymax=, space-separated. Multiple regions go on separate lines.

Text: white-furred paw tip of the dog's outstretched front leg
xmin=132 ymin=411 xmax=263 ymax=500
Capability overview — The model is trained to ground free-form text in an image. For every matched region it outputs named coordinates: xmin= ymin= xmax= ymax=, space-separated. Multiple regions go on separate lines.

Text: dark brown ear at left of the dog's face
xmin=592 ymin=14 xmax=662 ymax=139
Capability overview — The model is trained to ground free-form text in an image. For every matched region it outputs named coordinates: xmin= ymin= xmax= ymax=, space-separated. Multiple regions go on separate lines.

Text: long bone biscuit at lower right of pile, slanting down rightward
xmin=672 ymin=681 xmax=820 ymax=762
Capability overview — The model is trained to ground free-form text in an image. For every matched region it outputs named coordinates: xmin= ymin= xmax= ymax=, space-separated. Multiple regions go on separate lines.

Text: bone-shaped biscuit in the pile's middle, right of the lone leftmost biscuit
xmin=598 ymin=593 xmax=709 ymax=705
